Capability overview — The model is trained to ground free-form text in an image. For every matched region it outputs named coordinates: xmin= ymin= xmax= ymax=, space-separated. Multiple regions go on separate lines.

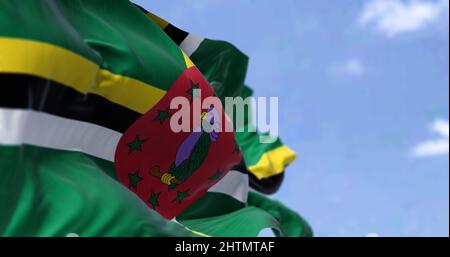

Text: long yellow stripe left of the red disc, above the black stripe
xmin=0 ymin=38 xmax=166 ymax=113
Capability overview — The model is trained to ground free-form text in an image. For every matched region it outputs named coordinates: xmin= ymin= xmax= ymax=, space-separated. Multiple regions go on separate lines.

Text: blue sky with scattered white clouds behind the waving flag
xmin=134 ymin=0 xmax=449 ymax=236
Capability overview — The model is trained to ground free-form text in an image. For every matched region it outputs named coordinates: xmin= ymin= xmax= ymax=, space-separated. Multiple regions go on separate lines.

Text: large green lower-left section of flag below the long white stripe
xmin=0 ymin=144 xmax=192 ymax=237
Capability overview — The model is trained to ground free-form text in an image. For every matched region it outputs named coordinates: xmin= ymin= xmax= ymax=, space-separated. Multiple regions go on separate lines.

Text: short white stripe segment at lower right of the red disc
xmin=208 ymin=170 xmax=249 ymax=203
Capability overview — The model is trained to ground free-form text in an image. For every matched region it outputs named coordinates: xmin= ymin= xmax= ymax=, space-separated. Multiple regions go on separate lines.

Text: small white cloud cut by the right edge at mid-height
xmin=412 ymin=120 xmax=449 ymax=157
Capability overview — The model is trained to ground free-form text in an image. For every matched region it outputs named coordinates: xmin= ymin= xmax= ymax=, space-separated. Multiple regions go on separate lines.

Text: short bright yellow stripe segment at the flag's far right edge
xmin=248 ymin=146 xmax=297 ymax=179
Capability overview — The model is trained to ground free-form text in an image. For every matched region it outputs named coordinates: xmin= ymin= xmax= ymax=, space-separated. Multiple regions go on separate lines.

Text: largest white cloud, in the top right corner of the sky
xmin=359 ymin=0 xmax=449 ymax=37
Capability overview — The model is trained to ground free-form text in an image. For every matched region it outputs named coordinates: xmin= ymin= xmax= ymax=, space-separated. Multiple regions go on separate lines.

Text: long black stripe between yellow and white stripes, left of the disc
xmin=0 ymin=74 xmax=141 ymax=133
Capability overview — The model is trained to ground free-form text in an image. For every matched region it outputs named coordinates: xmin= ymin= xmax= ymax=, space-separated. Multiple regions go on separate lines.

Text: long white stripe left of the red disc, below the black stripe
xmin=0 ymin=108 xmax=122 ymax=161
